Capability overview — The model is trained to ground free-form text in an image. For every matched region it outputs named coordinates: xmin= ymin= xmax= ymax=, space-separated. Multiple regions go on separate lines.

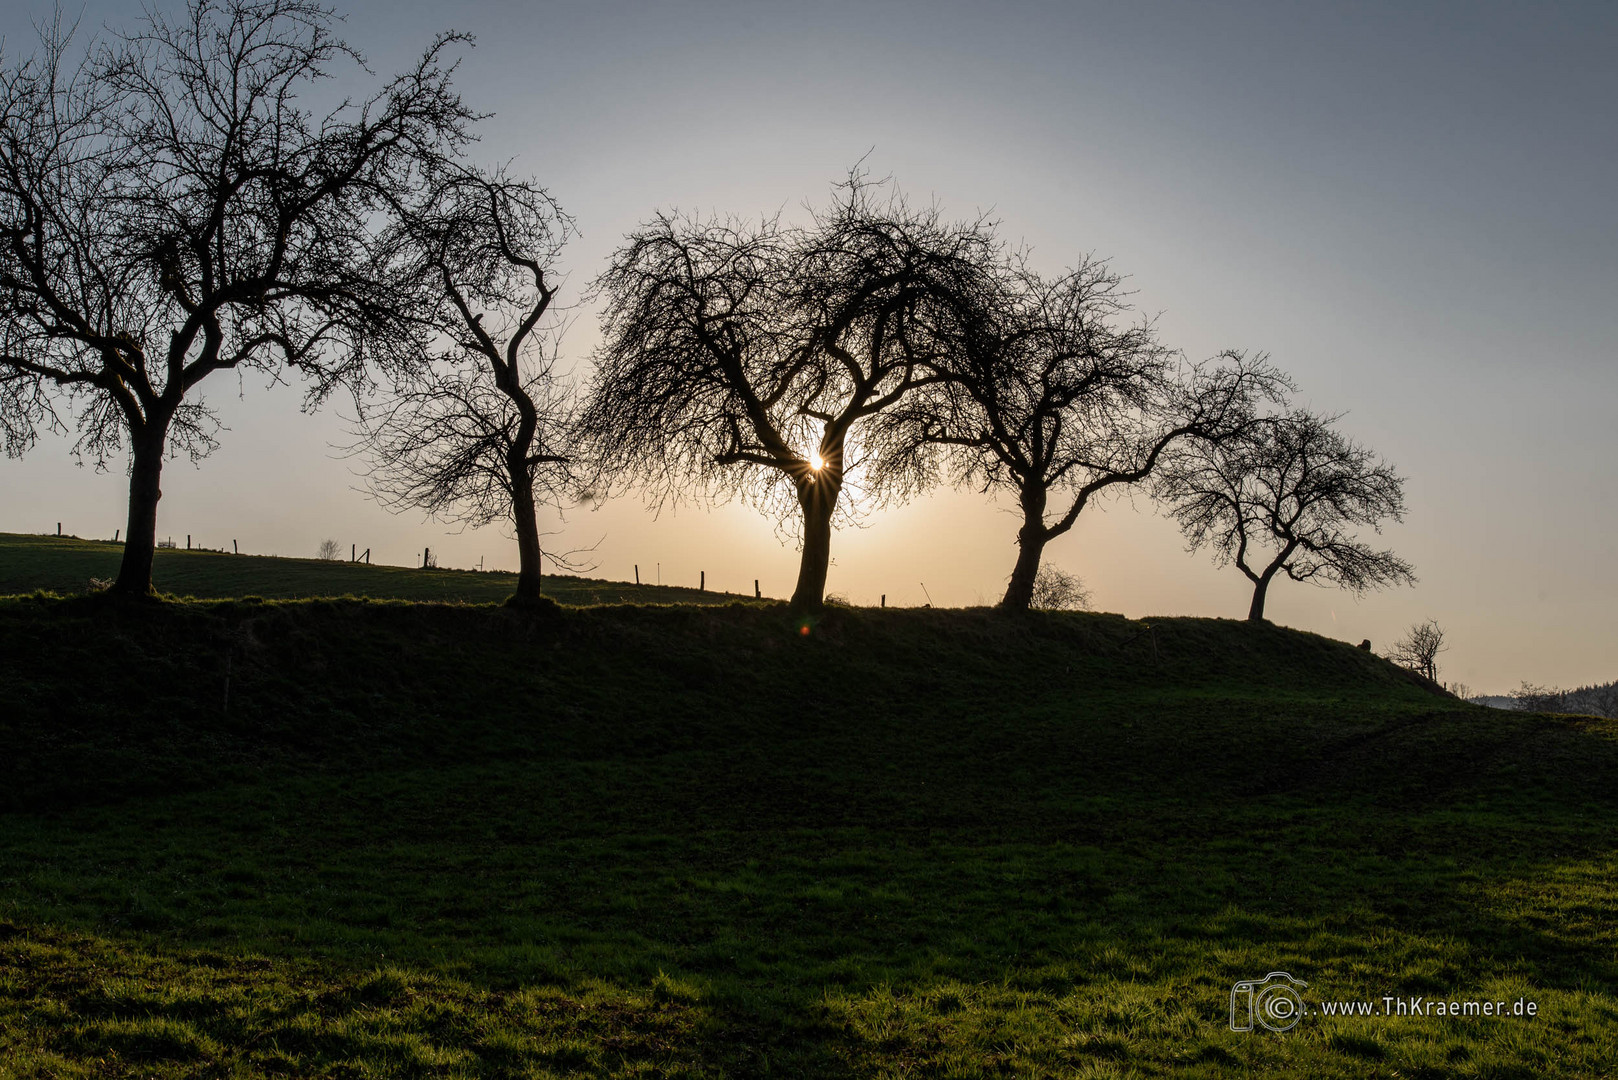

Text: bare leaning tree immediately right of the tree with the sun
xmin=882 ymin=250 xmax=1288 ymax=610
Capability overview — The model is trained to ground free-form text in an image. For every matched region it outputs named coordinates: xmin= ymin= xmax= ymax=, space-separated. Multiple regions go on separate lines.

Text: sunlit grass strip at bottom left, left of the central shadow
xmin=0 ymin=926 xmax=707 ymax=1077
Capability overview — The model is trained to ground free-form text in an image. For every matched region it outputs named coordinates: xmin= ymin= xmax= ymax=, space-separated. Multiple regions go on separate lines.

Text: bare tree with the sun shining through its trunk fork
xmin=581 ymin=181 xmax=993 ymax=610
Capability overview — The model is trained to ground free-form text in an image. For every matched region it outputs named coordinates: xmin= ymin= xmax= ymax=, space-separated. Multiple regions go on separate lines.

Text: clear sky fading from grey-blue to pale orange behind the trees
xmin=0 ymin=0 xmax=1618 ymax=691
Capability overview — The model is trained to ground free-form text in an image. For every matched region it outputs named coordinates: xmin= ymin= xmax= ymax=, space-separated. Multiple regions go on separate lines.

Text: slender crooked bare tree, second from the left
xmin=361 ymin=169 xmax=574 ymax=606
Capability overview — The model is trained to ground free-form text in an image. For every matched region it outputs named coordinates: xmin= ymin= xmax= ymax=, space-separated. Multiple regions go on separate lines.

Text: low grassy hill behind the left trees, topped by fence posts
xmin=0 ymin=533 xmax=751 ymax=604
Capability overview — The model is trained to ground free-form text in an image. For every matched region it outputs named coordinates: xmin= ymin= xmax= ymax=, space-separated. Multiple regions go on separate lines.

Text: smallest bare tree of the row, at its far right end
xmin=1157 ymin=411 xmax=1416 ymax=620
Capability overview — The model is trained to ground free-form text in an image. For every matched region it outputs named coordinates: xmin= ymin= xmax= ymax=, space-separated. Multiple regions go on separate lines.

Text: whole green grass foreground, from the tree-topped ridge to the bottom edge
xmin=0 ymin=537 xmax=1618 ymax=1078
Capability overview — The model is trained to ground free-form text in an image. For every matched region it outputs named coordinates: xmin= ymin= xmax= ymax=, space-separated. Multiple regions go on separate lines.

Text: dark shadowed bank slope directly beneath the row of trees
xmin=0 ymin=599 xmax=1459 ymax=806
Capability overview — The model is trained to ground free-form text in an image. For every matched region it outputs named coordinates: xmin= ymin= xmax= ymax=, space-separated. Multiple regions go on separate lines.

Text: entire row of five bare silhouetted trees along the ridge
xmin=0 ymin=0 xmax=1414 ymax=619
